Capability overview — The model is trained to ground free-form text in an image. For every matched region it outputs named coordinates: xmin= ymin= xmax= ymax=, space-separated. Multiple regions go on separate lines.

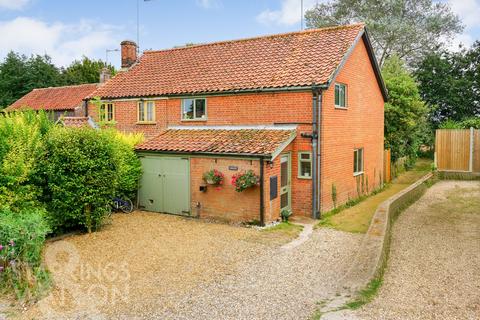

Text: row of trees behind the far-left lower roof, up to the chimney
xmin=0 ymin=51 xmax=115 ymax=110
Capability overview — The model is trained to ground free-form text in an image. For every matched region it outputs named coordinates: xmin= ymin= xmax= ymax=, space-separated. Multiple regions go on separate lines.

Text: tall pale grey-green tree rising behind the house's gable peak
xmin=305 ymin=0 xmax=463 ymax=66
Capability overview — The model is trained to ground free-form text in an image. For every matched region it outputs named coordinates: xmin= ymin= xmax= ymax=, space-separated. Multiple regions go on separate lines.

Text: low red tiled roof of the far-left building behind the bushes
xmin=7 ymin=83 xmax=98 ymax=111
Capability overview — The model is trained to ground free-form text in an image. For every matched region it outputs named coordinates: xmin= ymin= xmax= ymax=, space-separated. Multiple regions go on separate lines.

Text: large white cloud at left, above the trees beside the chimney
xmin=0 ymin=17 xmax=120 ymax=66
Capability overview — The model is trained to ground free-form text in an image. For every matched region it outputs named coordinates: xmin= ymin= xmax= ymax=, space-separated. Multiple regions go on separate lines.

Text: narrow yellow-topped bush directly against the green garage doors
xmin=103 ymin=130 xmax=144 ymax=199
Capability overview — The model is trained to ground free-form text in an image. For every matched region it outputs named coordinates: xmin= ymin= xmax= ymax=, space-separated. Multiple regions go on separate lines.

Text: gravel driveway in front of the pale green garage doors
xmin=20 ymin=212 xmax=362 ymax=319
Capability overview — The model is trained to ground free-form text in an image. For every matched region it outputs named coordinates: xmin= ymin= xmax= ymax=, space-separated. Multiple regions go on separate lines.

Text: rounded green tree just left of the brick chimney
xmin=63 ymin=57 xmax=115 ymax=85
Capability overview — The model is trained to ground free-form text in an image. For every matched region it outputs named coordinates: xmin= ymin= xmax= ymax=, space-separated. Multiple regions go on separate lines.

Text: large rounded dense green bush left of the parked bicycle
xmin=42 ymin=128 xmax=120 ymax=232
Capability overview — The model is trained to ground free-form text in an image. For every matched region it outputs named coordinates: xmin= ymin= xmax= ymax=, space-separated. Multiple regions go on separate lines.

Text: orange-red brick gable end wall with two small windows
xmin=321 ymin=41 xmax=384 ymax=211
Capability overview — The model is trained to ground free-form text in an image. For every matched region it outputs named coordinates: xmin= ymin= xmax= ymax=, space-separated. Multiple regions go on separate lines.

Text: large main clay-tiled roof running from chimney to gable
xmin=90 ymin=24 xmax=364 ymax=98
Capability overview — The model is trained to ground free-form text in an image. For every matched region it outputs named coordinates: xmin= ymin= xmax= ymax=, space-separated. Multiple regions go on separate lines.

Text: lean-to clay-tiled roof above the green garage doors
xmin=136 ymin=129 xmax=296 ymax=155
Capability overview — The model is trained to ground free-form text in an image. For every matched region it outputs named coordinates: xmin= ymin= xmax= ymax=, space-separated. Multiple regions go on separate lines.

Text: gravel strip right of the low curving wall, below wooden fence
xmin=350 ymin=181 xmax=480 ymax=319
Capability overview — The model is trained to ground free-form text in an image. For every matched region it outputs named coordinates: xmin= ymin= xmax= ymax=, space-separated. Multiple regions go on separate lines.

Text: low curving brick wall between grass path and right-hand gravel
xmin=344 ymin=173 xmax=433 ymax=290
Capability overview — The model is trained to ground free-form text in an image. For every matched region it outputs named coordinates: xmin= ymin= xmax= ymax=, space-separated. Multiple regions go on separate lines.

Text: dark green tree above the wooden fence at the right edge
xmin=415 ymin=41 xmax=480 ymax=127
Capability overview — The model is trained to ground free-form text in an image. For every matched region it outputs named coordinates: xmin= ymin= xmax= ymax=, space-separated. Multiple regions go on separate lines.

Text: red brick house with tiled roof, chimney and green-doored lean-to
xmin=88 ymin=24 xmax=387 ymax=223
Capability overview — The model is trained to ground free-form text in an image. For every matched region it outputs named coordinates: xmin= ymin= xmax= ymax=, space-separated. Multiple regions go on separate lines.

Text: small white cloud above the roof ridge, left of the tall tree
xmin=257 ymin=0 xmax=319 ymax=26
